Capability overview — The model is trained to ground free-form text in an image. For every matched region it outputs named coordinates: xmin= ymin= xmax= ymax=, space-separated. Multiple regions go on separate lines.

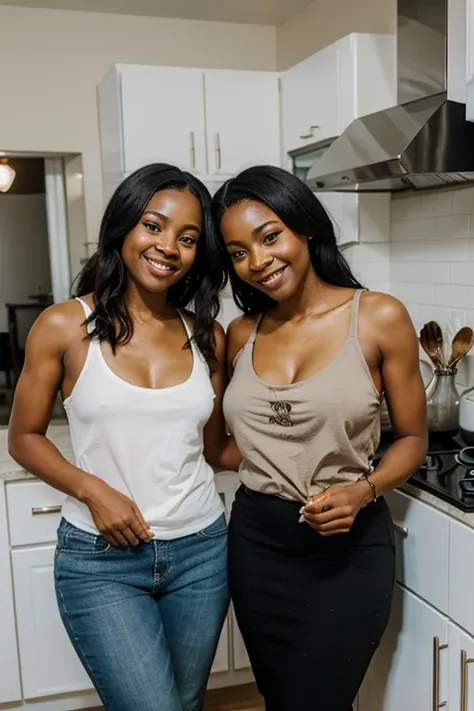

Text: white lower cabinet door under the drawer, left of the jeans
xmin=12 ymin=546 xmax=92 ymax=699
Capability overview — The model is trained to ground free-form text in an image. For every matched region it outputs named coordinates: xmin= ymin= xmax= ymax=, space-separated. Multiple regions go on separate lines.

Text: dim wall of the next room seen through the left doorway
xmin=0 ymin=193 xmax=51 ymax=340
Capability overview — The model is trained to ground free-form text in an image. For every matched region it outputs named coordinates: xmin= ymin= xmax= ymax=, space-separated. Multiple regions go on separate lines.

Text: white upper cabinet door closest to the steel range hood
xmin=281 ymin=44 xmax=338 ymax=154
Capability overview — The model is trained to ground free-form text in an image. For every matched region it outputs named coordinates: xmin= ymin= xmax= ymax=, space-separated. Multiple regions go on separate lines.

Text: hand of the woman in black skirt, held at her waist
xmin=302 ymin=480 xmax=372 ymax=536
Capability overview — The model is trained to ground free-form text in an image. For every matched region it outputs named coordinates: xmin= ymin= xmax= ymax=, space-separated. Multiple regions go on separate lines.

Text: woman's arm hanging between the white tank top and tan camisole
xmin=204 ymin=322 xmax=242 ymax=471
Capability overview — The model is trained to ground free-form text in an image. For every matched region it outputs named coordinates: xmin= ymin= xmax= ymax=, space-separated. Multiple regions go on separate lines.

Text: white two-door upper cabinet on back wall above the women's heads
xmin=98 ymin=65 xmax=280 ymax=187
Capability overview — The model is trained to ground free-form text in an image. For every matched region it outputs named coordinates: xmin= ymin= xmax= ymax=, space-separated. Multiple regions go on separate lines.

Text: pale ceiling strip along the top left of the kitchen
xmin=0 ymin=0 xmax=311 ymax=25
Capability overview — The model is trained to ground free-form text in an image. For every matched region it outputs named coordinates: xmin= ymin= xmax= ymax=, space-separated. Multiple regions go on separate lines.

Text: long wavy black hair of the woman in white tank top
xmin=74 ymin=163 xmax=223 ymax=372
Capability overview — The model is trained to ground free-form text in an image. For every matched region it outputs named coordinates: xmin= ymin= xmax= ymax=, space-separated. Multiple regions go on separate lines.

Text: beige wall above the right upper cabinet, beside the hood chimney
xmin=276 ymin=0 xmax=396 ymax=70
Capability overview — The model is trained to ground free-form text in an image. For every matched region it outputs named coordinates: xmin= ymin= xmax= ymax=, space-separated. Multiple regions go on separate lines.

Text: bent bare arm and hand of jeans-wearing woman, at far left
xmin=8 ymin=302 xmax=152 ymax=545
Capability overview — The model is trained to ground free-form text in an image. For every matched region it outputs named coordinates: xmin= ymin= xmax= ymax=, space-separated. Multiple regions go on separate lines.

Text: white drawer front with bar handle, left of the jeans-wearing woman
xmin=6 ymin=481 xmax=66 ymax=546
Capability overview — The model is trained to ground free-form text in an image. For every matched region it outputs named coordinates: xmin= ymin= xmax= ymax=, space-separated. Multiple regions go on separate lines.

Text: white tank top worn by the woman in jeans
xmin=62 ymin=299 xmax=224 ymax=540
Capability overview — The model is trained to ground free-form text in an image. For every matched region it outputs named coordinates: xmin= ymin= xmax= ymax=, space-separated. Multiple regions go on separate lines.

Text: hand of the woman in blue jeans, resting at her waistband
xmin=81 ymin=477 xmax=153 ymax=547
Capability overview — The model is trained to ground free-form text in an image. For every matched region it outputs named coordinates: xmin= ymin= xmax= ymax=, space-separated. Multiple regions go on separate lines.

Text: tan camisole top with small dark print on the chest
xmin=224 ymin=289 xmax=380 ymax=501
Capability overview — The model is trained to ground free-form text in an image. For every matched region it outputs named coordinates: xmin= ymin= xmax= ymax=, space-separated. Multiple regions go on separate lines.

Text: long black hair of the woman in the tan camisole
xmin=212 ymin=165 xmax=361 ymax=314
